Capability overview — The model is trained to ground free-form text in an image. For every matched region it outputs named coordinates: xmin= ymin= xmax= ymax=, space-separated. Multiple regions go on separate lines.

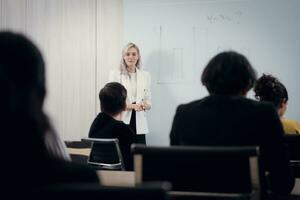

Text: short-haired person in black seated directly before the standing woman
xmin=89 ymin=82 xmax=136 ymax=170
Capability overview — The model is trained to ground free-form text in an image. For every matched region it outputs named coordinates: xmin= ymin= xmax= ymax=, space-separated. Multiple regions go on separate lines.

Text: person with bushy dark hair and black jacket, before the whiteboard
xmin=170 ymin=51 xmax=294 ymax=196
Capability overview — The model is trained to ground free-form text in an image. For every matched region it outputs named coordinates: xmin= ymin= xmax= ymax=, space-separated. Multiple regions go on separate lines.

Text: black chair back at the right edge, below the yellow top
xmin=284 ymin=134 xmax=300 ymax=178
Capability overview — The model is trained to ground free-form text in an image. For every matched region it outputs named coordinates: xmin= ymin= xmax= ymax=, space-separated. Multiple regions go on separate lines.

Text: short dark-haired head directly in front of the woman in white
xmin=99 ymin=82 xmax=127 ymax=116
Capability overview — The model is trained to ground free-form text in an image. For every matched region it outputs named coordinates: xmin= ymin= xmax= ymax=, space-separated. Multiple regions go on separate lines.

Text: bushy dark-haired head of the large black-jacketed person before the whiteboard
xmin=201 ymin=51 xmax=256 ymax=95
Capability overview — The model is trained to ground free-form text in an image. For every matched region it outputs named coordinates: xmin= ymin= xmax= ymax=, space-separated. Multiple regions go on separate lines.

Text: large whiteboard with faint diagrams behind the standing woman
xmin=123 ymin=0 xmax=300 ymax=145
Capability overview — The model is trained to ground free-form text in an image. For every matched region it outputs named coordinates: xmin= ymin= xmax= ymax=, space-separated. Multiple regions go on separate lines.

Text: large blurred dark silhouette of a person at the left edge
xmin=0 ymin=32 xmax=99 ymax=192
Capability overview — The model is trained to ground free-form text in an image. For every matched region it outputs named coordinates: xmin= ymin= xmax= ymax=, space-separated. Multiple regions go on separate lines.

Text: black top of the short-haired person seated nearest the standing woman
xmin=89 ymin=113 xmax=136 ymax=170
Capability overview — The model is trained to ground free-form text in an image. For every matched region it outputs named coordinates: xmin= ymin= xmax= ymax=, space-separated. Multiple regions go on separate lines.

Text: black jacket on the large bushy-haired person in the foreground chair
xmin=170 ymin=95 xmax=294 ymax=195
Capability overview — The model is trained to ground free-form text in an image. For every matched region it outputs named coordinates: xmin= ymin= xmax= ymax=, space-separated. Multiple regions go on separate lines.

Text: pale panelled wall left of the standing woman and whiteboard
xmin=0 ymin=0 xmax=123 ymax=140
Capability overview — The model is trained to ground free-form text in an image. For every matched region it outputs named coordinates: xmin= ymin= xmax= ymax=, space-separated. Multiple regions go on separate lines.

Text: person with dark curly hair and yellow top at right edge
xmin=254 ymin=74 xmax=300 ymax=134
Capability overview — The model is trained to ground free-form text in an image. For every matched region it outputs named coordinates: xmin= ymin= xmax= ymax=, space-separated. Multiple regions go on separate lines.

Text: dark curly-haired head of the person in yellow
xmin=254 ymin=74 xmax=288 ymax=108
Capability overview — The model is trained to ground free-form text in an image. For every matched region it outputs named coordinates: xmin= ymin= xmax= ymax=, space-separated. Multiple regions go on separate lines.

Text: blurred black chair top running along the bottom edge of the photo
xmin=27 ymin=183 xmax=170 ymax=200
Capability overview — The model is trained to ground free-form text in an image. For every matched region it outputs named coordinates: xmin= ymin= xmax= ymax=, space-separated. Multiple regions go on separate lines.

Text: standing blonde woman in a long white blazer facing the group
xmin=109 ymin=43 xmax=151 ymax=144
